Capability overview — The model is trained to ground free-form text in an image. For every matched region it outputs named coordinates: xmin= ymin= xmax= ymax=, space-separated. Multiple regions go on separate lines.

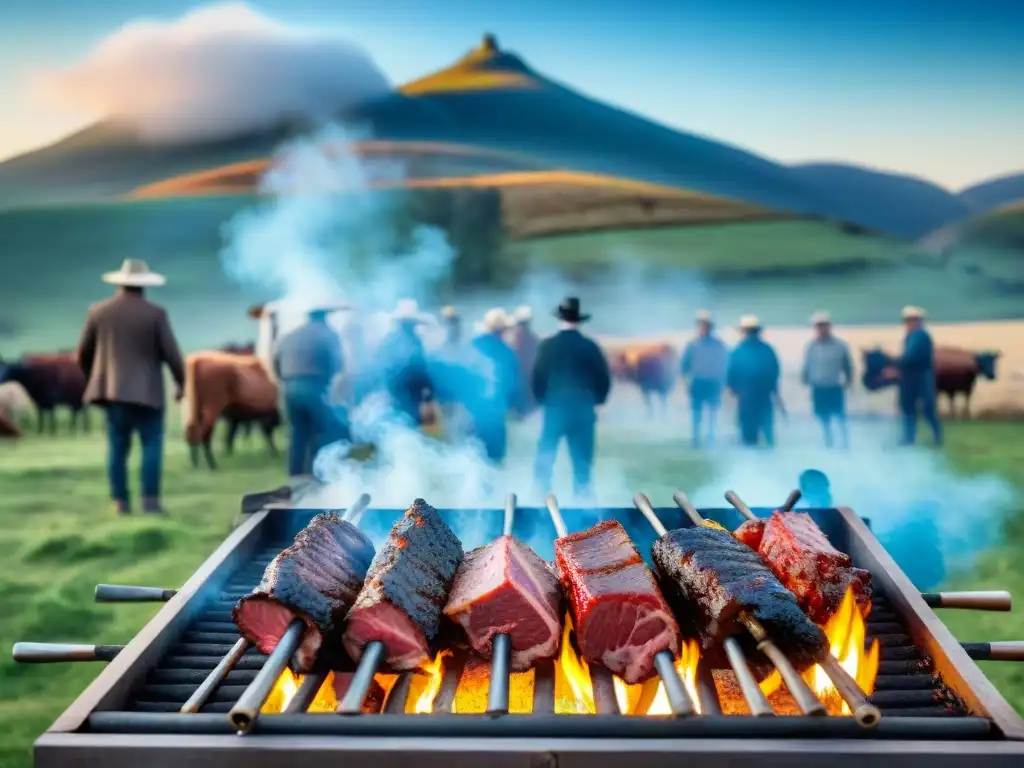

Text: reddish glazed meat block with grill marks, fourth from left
xmin=555 ymin=520 xmax=680 ymax=683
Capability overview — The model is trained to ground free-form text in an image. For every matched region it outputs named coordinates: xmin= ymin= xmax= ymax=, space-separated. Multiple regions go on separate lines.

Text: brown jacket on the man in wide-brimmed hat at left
xmin=78 ymin=292 xmax=185 ymax=409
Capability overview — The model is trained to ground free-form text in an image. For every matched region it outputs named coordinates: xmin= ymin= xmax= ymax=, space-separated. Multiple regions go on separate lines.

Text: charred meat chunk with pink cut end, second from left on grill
xmin=342 ymin=499 xmax=463 ymax=670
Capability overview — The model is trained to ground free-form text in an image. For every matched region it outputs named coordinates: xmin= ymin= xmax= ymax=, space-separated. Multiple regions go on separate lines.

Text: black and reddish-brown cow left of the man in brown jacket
xmin=0 ymin=352 xmax=91 ymax=434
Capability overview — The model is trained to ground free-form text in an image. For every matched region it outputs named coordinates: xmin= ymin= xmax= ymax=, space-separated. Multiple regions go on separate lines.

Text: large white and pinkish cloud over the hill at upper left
xmin=38 ymin=3 xmax=390 ymax=143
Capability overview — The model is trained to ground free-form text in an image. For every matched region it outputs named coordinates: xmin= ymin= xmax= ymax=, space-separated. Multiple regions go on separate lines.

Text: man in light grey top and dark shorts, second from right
xmin=801 ymin=312 xmax=853 ymax=449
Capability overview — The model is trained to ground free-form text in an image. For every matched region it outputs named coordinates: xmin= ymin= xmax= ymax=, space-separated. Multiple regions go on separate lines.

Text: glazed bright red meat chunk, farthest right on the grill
xmin=759 ymin=511 xmax=871 ymax=624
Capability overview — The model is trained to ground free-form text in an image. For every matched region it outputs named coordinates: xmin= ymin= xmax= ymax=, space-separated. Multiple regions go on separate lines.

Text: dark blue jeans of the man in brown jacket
xmin=104 ymin=402 xmax=164 ymax=504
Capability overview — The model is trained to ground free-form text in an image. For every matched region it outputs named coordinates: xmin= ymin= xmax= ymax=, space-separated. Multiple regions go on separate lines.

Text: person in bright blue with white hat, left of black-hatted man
xmin=470 ymin=308 xmax=522 ymax=464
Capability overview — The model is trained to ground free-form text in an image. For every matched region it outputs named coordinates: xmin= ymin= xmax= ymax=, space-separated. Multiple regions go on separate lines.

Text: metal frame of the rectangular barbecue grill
xmin=35 ymin=505 xmax=1024 ymax=768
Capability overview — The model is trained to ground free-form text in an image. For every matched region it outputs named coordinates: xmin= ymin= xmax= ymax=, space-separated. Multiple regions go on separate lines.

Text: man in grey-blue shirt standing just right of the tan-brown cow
xmin=273 ymin=308 xmax=347 ymax=477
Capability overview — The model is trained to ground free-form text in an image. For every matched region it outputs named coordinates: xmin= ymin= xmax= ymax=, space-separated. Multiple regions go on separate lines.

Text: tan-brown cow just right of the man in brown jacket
xmin=182 ymin=351 xmax=281 ymax=469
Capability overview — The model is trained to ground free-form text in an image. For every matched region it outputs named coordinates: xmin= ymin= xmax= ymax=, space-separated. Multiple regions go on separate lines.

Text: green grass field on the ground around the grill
xmin=0 ymin=414 xmax=1024 ymax=768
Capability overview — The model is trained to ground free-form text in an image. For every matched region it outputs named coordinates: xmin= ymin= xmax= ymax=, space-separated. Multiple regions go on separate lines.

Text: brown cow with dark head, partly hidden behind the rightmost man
xmin=861 ymin=346 xmax=1000 ymax=419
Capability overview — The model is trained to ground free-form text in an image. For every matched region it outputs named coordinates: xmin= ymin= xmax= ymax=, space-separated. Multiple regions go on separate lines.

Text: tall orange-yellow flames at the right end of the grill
xmin=761 ymin=588 xmax=879 ymax=715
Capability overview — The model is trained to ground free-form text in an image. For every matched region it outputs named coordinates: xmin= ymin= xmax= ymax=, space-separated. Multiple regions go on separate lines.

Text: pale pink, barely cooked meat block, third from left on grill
xmin=444 ymin=536 xmax=562 ymax=672
